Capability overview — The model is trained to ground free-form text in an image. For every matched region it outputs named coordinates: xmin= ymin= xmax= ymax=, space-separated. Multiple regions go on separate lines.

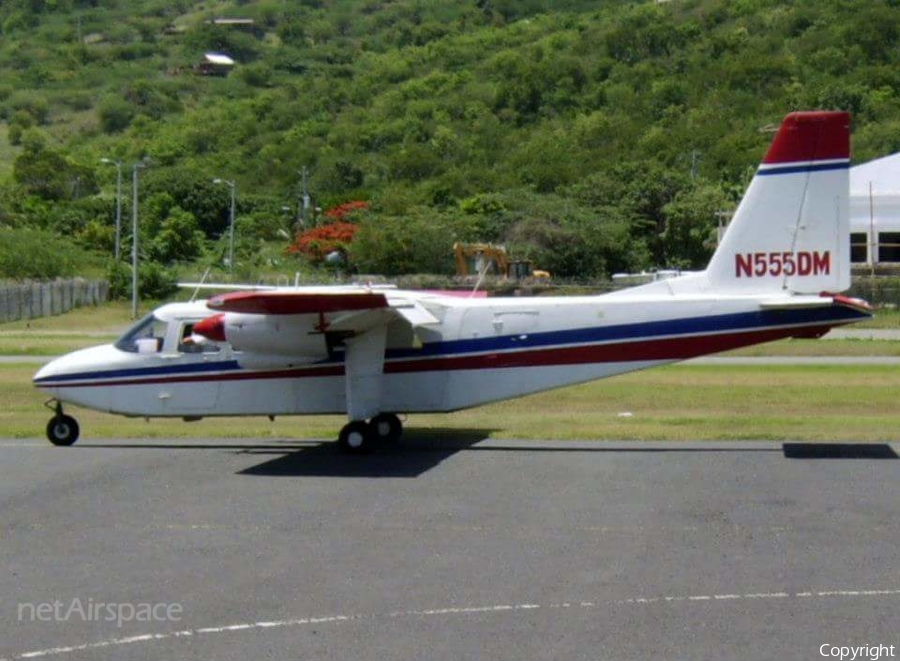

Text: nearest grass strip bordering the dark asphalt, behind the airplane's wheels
xmin=7 ymin=365 xmax=900 ymax=442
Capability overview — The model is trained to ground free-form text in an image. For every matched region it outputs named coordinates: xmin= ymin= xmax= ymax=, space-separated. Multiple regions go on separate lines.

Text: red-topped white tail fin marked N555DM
xmin=706 ymin=111 xmax=850 ymax=294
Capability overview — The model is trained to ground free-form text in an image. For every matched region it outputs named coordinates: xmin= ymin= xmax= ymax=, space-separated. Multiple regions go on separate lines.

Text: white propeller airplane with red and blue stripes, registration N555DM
xmin=34 ymin=111 xmax=872 ymax=453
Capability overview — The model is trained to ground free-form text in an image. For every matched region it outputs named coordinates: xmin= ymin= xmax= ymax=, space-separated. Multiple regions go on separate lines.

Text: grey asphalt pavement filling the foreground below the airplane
xmin=0 ymin=436 xmax=900 ymax=661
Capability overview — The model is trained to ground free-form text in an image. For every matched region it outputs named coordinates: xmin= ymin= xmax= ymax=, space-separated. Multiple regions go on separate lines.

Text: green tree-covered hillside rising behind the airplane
xmin=0 ymin=0 xmax=900 ymax=278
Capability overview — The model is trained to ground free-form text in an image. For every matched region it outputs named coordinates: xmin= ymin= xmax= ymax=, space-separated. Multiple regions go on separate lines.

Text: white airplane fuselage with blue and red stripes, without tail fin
xmin=35 ymin=284 xmax=868 ymax=417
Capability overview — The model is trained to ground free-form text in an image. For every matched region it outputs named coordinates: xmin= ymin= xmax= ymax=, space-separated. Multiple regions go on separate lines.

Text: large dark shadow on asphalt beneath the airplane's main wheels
xmin=238 ymin=428 xmax=492 ymax=478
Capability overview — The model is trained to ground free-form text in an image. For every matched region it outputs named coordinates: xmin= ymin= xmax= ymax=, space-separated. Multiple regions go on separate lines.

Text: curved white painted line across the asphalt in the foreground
xmin=7 ymin=589 xmax=900 ymax=661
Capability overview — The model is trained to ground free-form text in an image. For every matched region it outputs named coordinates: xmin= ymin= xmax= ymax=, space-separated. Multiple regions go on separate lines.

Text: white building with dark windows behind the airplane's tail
xmin=850 ymin=153 xmax=900 ymax=266
